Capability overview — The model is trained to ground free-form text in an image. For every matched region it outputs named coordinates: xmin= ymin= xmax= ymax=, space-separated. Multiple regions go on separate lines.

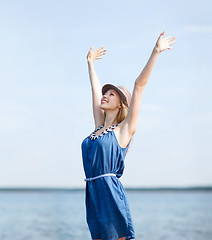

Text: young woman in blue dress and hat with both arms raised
xmin=81 ymin=32 xmax=175 ymax=240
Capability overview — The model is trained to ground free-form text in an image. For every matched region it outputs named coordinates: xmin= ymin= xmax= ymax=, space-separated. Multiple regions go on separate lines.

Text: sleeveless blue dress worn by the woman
xmin=81 ymin=125 xmax=135 ymax=240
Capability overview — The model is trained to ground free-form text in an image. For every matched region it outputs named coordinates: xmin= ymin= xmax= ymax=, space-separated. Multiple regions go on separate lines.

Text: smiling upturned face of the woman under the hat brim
xmin=100 ymin=89 xmax=121 ymax=110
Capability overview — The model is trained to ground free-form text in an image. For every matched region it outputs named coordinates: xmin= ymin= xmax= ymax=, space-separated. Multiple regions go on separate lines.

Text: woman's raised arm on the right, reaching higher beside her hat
xmin=120 ymin=31 xmax=175 ymax=139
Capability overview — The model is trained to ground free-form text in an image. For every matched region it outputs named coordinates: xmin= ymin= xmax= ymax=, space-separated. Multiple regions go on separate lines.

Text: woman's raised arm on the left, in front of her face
xmin=87 ymin=46 xmax=106 ymax=128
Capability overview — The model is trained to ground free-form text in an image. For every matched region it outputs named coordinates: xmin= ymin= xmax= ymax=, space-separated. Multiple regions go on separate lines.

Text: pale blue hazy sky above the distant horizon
xmin=0 ymin=0 xmax=212 ymax=188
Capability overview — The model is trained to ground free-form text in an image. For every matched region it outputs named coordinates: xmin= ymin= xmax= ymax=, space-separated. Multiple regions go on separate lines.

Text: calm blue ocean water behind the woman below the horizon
xmin=0 ymin=191 xmax=212 ymax=240
